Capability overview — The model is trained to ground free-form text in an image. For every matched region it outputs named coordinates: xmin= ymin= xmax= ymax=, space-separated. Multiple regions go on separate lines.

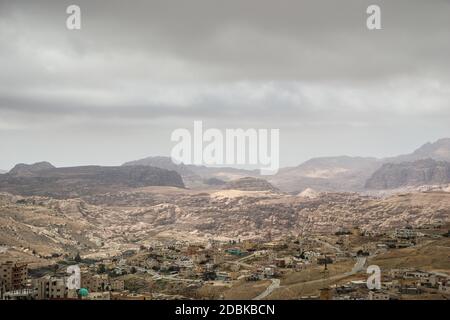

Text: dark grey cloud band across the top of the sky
xmin=2 ymin=0 xmax=450 ymax=81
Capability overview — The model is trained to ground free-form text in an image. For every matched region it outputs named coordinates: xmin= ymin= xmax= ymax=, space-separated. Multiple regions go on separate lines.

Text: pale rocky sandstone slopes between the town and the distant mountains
xmin=0 ymin=187 xmax=450 ymax=262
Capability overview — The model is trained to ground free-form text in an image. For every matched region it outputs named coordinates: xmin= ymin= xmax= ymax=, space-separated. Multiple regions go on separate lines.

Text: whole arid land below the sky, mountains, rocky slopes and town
xmin=0 ymin=139 xmax=450 ymax=299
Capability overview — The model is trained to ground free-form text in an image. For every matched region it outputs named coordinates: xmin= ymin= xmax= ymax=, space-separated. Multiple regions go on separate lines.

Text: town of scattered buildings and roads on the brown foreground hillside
xmin=0 ymin=224 xmax=450 ymax=300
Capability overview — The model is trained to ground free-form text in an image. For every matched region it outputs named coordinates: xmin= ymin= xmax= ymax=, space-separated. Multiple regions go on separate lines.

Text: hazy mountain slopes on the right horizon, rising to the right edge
xmin=268 ymin=138 xmax=450 ymax=192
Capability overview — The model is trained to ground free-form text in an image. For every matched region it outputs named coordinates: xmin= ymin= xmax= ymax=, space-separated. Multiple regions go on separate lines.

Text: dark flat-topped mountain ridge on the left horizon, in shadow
xmin=0 ymin=162 xmax=184 ymax=198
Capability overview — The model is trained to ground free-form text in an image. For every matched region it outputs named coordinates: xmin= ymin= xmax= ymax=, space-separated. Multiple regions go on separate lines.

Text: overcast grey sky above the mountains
xmin=0 ymin=0 xmax=450 ymax=169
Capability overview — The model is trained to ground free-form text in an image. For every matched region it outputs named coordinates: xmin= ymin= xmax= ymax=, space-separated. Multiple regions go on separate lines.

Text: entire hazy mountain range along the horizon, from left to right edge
xmin=0 ymin=138 xmax=450 ymax=196
